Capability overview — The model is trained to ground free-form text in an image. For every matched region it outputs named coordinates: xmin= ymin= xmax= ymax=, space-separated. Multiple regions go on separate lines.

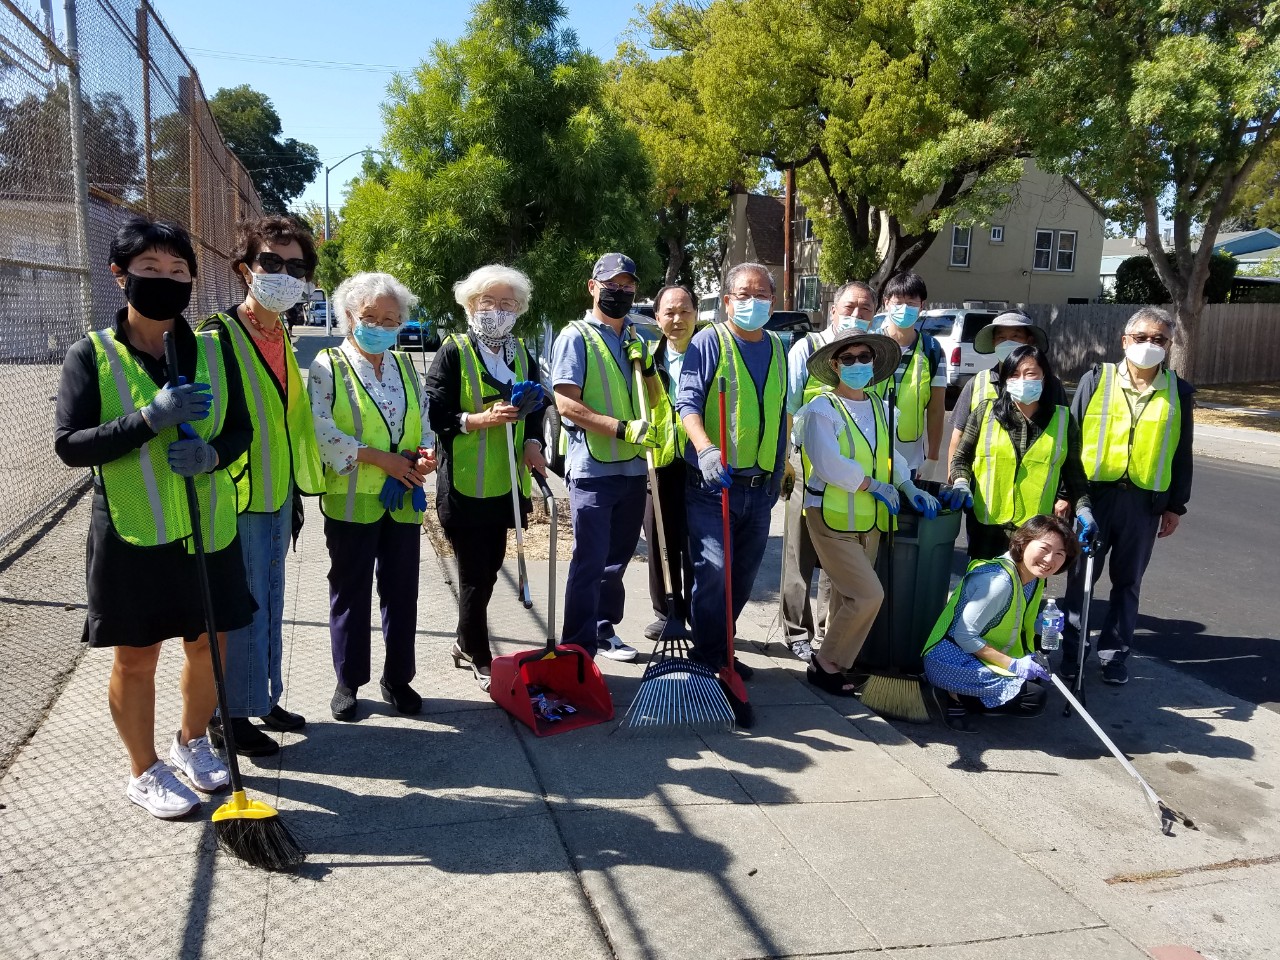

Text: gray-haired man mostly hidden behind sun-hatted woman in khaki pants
xmin=781 ymin=280 xmax=876 ymax=663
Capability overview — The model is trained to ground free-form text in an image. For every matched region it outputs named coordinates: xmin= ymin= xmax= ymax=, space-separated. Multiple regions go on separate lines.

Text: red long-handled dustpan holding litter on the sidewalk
xmin=489 ymin=470 xmax=613 ymax=737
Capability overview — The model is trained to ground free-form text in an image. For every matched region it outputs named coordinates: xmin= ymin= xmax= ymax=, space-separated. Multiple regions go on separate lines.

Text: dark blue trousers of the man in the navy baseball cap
xmin=561 ymin=476 xmax=646 ymax=657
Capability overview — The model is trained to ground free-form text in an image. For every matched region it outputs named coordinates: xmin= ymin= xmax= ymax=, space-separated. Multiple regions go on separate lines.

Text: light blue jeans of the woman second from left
xmin=223 ymin=497 xmax=293 ymax=717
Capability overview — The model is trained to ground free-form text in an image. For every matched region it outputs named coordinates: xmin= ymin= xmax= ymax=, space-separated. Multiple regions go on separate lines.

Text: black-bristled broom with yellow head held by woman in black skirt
xmin=164 ymin=333 xmax=306 ymax=870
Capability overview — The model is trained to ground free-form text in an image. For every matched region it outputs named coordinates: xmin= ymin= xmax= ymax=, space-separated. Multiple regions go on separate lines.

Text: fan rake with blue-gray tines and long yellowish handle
xmin=626 ymin=361 xmax=733 ymax=733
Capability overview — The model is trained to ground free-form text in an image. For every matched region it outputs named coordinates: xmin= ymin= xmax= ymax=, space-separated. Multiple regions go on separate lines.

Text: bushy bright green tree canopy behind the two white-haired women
xmin=343 ymin=0 xmax=662 ymax=324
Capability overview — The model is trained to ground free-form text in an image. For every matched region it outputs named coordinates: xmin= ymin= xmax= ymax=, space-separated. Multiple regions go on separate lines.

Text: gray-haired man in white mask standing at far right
xmin=1057 ymin=307 xmax=1196 ymax=685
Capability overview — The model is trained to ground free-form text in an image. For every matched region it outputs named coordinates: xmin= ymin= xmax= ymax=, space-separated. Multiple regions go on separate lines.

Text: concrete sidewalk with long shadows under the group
xmin=0 ymin=481 xmax=1280 ymax=960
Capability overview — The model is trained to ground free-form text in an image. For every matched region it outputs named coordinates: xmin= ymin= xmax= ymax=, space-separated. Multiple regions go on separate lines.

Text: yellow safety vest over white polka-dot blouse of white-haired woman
xmin=320 ymin=347 xmax=422 ymax=524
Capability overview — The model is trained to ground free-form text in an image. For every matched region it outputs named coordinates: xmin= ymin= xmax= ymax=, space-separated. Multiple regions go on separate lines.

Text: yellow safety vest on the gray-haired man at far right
xmin=1080 ymin=364 xmax=1183 ymax=493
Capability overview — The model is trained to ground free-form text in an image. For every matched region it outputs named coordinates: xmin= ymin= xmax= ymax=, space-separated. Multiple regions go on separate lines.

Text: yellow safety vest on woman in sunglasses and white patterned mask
xmin=200 ymin=311 xmax=324 ymax=513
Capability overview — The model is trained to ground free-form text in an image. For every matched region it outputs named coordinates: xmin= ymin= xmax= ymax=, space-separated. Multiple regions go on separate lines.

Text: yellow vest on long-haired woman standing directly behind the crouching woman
xmin=973 ymin=403 xmax=1069 ymax=526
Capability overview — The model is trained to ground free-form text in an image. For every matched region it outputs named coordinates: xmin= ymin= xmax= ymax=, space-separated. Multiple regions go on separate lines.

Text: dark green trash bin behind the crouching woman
xmin=854 ymin=483 xmax=964 ymax=673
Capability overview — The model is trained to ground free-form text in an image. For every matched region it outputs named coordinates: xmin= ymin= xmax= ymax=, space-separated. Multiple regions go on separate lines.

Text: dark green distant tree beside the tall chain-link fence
xmin=209 ymin=83 xmax=320 ymax=214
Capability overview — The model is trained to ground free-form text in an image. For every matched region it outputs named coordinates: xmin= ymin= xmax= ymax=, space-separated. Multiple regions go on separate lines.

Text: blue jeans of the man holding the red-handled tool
xmin=685 ymin=475 xmax=777 ymax=671
